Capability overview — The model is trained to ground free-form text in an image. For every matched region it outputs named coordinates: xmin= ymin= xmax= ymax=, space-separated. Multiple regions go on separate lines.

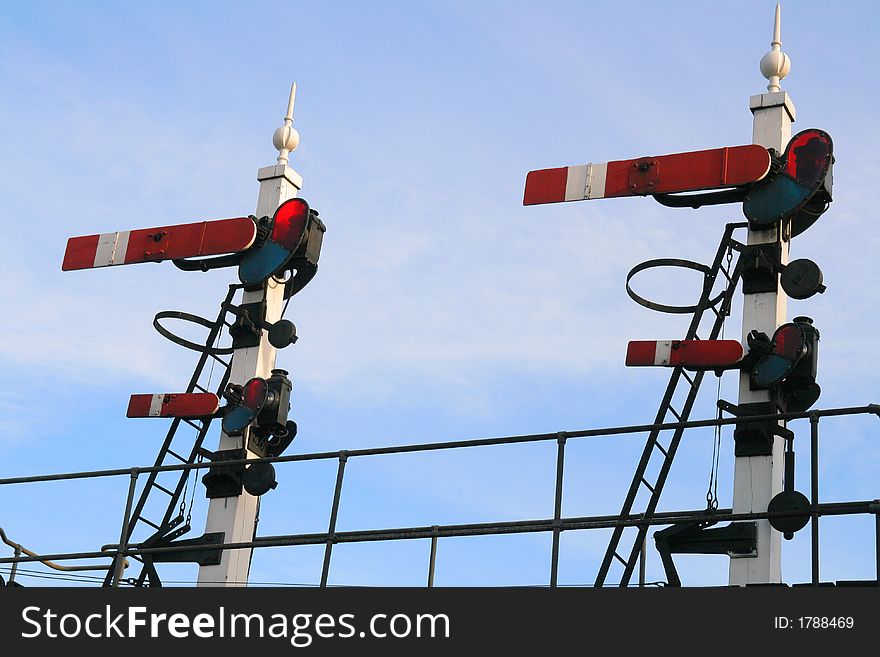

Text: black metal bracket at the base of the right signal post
xmin=654 ymin=520 xmax=758 ymax=586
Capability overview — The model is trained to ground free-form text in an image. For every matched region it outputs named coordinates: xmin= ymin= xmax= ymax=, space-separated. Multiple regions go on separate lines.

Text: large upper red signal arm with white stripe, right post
xmin=523 ymin=144 xmax=770 ymax=205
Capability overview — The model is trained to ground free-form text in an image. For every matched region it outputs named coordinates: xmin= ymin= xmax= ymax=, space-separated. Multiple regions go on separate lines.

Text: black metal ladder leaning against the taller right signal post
xmin=594 ymin=223 xmax=746 ymax=587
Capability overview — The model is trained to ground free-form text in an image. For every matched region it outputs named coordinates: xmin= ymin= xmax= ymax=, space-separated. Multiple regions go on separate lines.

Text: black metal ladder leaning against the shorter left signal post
xmin=104 ymin=285 xmax=242 ymax=586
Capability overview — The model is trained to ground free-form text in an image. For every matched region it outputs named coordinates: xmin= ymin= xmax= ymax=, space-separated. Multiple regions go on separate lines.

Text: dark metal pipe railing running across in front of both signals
xmin=0 ymin=404 xmax=880 ymax=587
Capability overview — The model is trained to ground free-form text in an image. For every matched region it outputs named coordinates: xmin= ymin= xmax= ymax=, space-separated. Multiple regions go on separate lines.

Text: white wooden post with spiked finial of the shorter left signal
xmin=198 ymin=82 xmax=302 ymax=586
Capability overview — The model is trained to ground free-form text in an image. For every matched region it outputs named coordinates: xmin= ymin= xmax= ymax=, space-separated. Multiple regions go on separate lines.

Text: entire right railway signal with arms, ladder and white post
xmin=523 ymin=5 xmax=834 ymax=586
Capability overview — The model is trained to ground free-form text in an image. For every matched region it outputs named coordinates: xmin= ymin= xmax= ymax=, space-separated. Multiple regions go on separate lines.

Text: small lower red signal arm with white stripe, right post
xmin=626 ymin=340 xmax=745 ymax=370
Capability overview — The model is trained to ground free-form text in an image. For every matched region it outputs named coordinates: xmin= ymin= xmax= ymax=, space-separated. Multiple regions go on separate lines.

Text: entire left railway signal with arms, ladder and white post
xmin=62 ymin=83 xmax=325 ymax=586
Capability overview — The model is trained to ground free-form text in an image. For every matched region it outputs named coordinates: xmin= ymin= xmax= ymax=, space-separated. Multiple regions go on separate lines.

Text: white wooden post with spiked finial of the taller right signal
xmin=729 ymin=4 xmax=795 ymax=586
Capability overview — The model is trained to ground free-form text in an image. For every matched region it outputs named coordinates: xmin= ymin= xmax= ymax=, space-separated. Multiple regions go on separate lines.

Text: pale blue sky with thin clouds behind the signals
xmin=0 ymin=0 xmax=880 ymax=585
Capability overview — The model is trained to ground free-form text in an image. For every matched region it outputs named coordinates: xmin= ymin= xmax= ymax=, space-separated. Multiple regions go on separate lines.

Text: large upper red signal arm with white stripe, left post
xmin=61 ymin=217 xmax=257 ymax=271
